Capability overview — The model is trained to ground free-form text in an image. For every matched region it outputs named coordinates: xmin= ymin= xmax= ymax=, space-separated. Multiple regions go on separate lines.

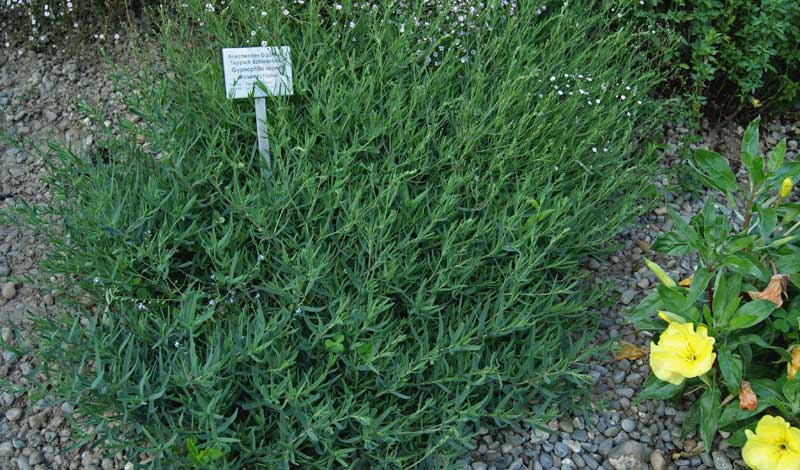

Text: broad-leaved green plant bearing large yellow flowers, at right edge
xmin=631 ymin=119 xmax=800 ymax=462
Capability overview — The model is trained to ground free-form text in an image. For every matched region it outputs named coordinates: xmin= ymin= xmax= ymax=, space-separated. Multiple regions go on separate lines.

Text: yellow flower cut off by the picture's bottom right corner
xmin=742 ymin=415 xmax=800 ymax=470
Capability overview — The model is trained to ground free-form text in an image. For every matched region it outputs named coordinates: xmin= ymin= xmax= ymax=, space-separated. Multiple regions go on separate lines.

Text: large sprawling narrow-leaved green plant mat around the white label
xmin=18 ymin=1 xmax=654 ymax=468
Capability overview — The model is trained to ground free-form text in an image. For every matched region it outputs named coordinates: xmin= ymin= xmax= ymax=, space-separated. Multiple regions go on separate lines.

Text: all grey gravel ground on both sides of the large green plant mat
xmin=0 ymin=31 xmax=800 ymax=470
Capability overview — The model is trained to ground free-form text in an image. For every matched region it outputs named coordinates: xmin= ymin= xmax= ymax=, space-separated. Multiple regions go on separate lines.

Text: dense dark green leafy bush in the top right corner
xmin=636 ymin=0 xmax=800 ymax=119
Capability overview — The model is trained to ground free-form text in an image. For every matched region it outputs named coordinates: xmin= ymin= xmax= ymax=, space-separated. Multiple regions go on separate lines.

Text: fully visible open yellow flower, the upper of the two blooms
xmin=650 ymin=317 xmax=717 ymax=385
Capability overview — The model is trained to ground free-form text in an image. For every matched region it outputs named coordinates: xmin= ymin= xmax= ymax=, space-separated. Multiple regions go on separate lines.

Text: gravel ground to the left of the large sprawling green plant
xmin=0 ymin=34 xmax=152 ymax=470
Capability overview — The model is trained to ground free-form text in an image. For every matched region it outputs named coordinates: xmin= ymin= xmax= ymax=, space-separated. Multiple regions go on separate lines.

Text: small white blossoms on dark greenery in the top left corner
xmin=0 ymin=0 xmax=120 ymax=48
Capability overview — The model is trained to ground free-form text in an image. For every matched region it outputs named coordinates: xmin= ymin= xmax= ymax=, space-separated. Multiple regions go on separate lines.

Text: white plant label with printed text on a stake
xmin=222 ymin=46 xmax=293 ymax=171
